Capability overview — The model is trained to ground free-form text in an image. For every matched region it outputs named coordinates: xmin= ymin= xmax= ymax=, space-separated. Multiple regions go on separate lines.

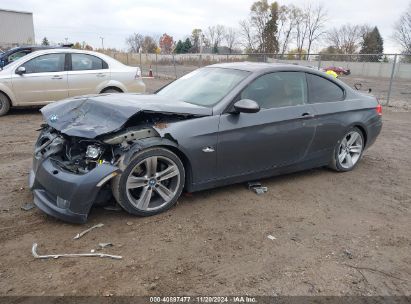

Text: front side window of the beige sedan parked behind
xmin=21 ymin=53 xmax=66 ymax=74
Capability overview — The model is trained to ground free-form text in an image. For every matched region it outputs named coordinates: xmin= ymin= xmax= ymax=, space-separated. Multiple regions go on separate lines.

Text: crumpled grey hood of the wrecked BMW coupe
xmin=40 ymin=94 xmax=212 ymax=139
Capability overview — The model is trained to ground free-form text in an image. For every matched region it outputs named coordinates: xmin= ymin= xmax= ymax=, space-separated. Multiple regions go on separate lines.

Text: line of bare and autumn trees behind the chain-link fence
xmin=43 ymin=0 xmax=411 ymax=61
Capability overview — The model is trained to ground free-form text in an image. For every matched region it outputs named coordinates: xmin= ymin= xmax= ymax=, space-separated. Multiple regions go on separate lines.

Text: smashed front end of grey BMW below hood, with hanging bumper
xmin=30 ymin=120 xmax=166 ymax=223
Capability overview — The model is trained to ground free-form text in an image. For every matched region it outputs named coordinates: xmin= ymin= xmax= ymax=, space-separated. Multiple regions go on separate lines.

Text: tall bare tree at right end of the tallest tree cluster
xmin=306 ymin=4 xmax=327 ymax=54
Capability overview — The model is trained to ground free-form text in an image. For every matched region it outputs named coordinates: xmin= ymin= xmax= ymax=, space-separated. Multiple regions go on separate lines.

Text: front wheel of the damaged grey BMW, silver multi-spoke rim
xmin=111 ymin=147 xmax=185 ymax=216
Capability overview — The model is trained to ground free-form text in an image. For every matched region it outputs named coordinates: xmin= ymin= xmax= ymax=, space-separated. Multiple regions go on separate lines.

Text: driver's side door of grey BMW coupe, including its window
xmin=217 ymin=72 xmax=315 ymax=178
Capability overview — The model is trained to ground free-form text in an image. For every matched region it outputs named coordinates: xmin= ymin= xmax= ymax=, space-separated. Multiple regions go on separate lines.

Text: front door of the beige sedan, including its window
xmin=12 ymin=53 xmax=68 ymax=104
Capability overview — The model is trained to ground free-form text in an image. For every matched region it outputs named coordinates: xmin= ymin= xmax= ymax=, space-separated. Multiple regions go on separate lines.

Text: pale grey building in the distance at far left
xmin=0 ymin=9 xmax=35 ymax=49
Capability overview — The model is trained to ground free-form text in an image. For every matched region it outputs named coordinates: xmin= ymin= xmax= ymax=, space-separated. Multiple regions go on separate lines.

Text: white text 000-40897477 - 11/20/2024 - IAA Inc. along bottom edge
xmin=150 ymin=296 xmax=257 ymax=303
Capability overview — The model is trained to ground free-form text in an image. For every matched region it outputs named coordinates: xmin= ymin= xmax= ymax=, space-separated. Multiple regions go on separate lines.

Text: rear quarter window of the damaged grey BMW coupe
xmin=307 ymin=74 xmax=344 ymax=103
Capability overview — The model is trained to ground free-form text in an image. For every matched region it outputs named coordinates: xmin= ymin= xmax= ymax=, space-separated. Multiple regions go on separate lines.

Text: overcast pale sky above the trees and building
xmin=0 ymin=0 xmax=409 ymax=53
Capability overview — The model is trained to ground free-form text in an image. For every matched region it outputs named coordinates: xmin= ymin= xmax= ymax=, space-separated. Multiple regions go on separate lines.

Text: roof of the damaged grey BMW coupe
xmin=208 ymin=61 xmax=313 ymax=72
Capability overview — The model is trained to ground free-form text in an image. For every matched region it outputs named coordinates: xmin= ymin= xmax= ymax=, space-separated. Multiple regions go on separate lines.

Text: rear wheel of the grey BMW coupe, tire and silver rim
xmin=329 ymin=127 xmax=365 ymax=172
